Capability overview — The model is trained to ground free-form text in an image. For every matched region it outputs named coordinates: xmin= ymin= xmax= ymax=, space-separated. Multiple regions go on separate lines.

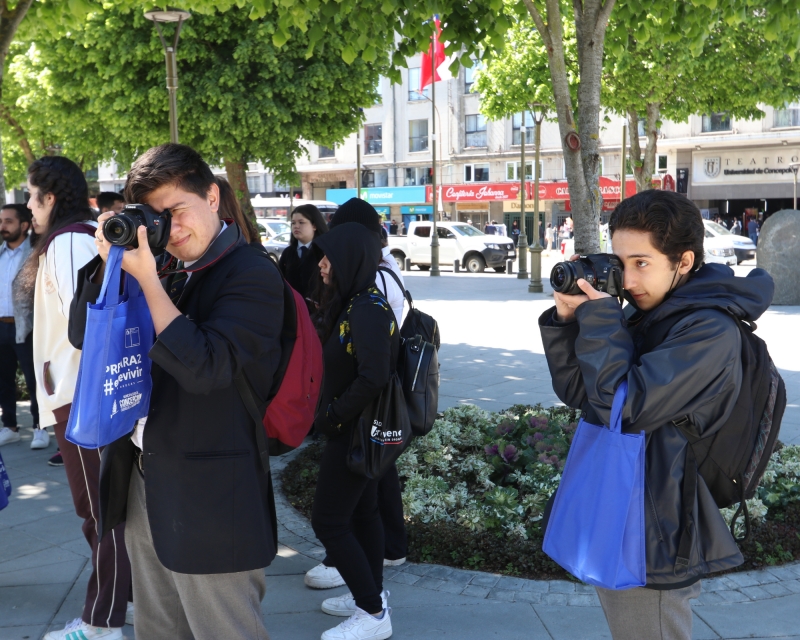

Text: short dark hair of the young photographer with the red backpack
xmin=125 ymin=142 xmax=216 ymax=203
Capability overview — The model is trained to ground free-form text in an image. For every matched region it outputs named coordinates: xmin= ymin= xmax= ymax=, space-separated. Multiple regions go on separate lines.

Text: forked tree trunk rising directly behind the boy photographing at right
xmin=524 ymin=0 xmax=615 ymax=254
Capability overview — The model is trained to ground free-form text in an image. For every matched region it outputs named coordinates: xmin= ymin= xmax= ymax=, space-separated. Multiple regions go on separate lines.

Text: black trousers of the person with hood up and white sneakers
xmin=311 ymin=437 xmax=384 ymax=613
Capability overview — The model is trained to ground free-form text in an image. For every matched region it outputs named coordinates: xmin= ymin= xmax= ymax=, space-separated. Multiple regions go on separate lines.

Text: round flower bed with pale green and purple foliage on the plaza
xmin=283 ymin=405 xmax=800 ymax=579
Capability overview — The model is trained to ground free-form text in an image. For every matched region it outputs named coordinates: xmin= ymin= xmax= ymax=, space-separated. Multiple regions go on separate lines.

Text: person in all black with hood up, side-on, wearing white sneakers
xmin=311 ymin=222 xmax=400 ymax=640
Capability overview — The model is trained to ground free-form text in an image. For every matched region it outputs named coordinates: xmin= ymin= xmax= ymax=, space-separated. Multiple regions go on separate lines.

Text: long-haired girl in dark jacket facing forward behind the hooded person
xmin=278 ymin=204 xmax=328 ymax=298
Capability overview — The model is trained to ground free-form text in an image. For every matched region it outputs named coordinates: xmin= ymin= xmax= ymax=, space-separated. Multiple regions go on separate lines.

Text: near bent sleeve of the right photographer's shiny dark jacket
xmin=568 ymin=298 xmax=742 ymax=434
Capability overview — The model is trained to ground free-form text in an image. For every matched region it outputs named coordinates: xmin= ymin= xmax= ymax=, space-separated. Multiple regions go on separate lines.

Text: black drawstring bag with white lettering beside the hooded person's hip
xmin=347 ymin=373 xmax=411 ymax=480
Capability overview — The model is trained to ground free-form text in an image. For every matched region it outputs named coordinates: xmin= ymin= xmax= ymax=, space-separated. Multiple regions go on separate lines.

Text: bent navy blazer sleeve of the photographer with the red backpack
xmin=150 ymin=265 xmax=283 ymax=394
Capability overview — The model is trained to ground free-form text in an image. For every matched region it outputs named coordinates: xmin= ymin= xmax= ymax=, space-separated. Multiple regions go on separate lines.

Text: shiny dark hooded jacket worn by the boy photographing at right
xmin=539 ymin=264 xmax=774 ymax=589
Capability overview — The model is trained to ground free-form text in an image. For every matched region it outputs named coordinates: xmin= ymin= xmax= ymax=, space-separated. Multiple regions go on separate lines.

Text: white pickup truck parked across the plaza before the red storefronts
xmin=389 ymin=221 xmax=517 ymax=273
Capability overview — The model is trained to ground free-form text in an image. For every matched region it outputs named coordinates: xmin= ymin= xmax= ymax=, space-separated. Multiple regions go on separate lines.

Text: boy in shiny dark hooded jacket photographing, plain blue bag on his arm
xmin=539 ymin=190 xmax=774 ymax=640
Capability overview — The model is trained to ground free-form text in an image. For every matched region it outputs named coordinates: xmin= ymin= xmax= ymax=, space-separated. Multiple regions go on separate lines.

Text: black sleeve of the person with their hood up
xmin=329 ymin=302 xmax=398 ymax=422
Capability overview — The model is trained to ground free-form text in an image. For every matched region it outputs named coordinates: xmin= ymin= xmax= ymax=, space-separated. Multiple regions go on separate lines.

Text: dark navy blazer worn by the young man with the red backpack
xmin=70 ymin=225 xmax=283 ymax=574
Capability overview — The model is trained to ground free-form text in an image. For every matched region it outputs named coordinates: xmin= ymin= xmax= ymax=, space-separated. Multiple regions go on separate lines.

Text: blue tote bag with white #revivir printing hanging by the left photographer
xmin=66 ymin=246 xmax=155 ymax=449
